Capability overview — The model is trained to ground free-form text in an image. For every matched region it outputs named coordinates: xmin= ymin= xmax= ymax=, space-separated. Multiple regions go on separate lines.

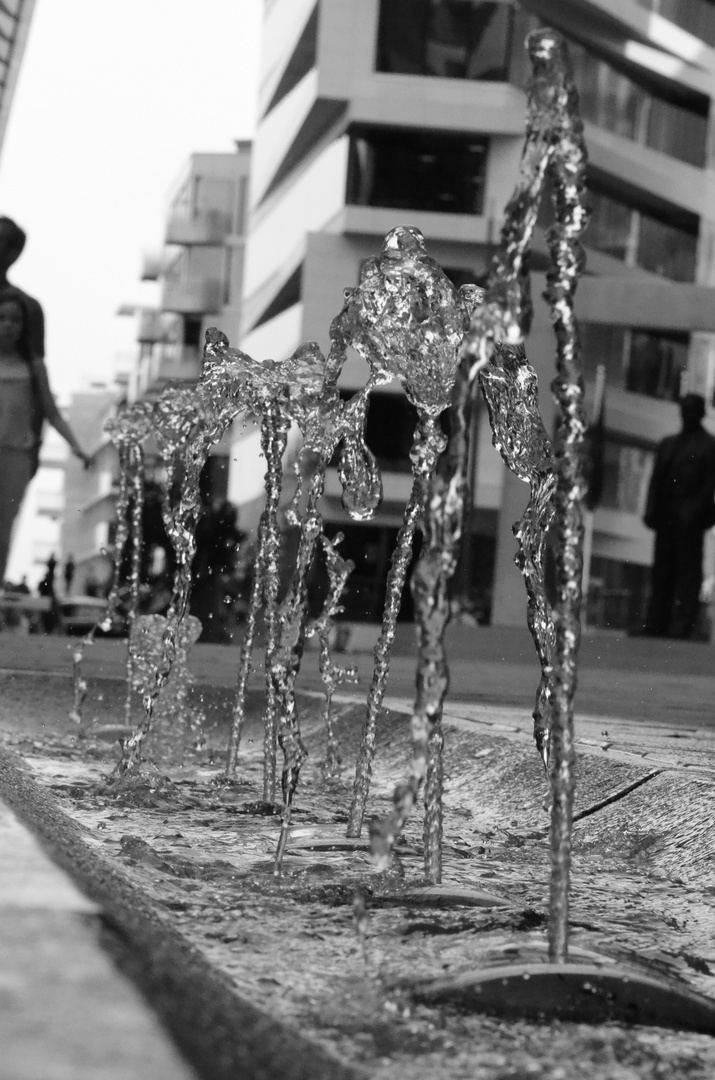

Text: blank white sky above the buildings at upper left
xmin=0 ymin=0 xmax=262 ymax=397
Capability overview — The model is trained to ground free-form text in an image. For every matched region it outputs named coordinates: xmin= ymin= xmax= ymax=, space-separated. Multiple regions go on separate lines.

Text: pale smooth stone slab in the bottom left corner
xmin=0 ymin=801 xmax=195 ymax=1080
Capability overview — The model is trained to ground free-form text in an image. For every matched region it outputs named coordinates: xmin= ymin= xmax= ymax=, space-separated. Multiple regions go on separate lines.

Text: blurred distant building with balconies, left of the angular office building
xmin=56 ymin=141 xmax=251 ymax=593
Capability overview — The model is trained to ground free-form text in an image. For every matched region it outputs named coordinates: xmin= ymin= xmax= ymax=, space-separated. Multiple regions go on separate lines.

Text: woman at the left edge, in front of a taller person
xmin=0 ymin=285 xmax=90 ymax=584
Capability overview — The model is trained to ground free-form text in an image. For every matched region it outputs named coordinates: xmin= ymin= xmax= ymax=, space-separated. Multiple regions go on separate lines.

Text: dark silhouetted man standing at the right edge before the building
xmin=644 ymin=394 xmax=715 ymax=637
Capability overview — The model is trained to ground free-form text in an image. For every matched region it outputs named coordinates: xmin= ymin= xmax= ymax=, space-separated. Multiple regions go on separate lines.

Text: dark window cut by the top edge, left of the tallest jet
xmin=376 ymin=0 xmax=531 ymax=82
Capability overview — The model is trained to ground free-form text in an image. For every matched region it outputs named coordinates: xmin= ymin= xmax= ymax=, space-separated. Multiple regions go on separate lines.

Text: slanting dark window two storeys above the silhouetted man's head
xmin=584 ymin=187 xmax=699 ymax=281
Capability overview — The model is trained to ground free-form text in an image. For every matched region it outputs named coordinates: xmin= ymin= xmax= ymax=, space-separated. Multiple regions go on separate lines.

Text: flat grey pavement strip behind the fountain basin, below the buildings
xmin=0 ymin=624 xmax=715 ymax=745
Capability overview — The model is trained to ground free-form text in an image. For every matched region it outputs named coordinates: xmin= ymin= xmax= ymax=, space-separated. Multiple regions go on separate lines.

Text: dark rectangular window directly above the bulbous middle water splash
xmin=348 ymin=127 xmax=488 ymax=214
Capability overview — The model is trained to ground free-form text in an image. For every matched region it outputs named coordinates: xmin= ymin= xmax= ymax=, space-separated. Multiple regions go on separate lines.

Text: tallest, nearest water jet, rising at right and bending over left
xmin=464 ymin=29 xmax=589 ymax=962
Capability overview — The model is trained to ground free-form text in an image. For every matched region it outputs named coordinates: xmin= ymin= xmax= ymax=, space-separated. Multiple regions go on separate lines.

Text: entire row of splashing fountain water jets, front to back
xmin=89 ymin=23 xmax=588 ymax=980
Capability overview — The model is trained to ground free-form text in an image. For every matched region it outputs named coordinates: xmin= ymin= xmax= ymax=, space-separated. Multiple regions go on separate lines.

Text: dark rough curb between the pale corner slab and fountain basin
xmin=0 ymin=750 xmax=366 ymax=1080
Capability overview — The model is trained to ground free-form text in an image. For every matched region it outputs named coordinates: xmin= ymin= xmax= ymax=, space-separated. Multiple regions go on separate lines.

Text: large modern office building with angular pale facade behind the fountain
xmin=229 ymin=0 xmax=715 ymax=625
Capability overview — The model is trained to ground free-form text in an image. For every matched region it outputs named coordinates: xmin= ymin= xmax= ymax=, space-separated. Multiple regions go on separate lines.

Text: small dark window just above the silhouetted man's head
xmin=579 ymin=323 xmax=690 ymax=402
